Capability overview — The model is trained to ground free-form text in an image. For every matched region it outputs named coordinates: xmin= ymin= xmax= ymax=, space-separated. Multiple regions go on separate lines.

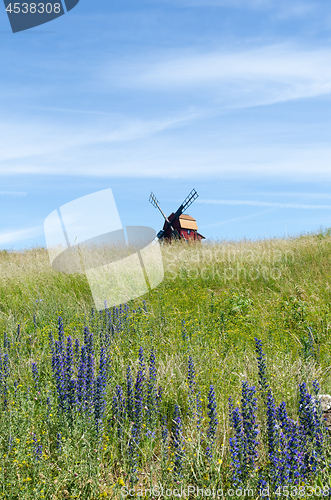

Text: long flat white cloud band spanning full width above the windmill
xmin=0 ymin=140 xmax=331 ymax=181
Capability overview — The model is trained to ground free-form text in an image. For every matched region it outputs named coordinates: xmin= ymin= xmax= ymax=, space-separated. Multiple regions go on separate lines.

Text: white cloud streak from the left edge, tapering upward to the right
xmin=0 ymin=112 xmax=199 ymax=163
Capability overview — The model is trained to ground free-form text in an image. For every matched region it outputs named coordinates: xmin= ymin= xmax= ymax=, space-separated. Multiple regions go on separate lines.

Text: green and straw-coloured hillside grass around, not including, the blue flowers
xmin=0 ymin=231 xmax=331 ymax=500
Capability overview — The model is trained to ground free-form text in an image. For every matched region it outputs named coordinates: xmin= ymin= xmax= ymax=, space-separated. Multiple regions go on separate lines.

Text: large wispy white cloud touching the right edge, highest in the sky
xmin=112 ymin=43 xmax=331 ymax=107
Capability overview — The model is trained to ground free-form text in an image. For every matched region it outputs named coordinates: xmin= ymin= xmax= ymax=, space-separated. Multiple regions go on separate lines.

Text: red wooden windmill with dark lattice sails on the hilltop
xmin=149 ymin=189 xmax=204 ymax=241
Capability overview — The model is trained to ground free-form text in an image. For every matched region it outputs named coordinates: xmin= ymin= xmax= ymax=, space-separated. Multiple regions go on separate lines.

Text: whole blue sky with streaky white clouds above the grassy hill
xmin=0 ymin=0 xmax=331 ymax=249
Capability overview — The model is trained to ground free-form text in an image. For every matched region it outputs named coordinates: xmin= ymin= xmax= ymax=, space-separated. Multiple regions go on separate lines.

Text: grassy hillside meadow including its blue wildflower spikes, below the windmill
xmin=0 ymin=231 xmax=331 ymax=500
